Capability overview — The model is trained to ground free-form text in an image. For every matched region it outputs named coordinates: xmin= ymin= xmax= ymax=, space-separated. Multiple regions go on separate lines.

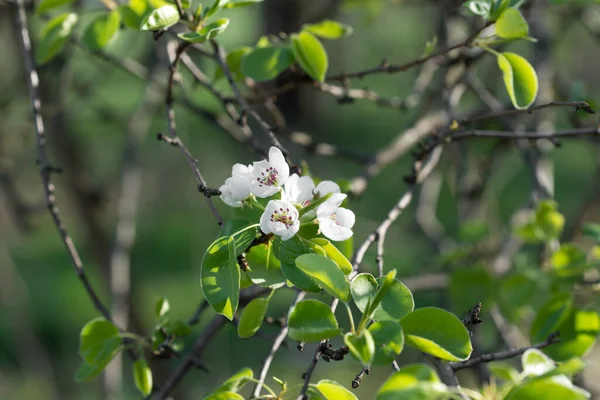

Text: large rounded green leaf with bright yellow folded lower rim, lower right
xmin=400 ymin=307 xmax=473 ymax=361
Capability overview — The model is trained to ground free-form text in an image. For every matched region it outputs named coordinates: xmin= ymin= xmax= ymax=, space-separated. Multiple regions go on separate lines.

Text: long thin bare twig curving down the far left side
xmin=16 ymin=0 xmax=112 ymax=320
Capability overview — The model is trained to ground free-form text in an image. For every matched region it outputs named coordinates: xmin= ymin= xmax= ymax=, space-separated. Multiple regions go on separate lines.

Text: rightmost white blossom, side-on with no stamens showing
xmin=317 ymin=193 xmax=355 ymax=241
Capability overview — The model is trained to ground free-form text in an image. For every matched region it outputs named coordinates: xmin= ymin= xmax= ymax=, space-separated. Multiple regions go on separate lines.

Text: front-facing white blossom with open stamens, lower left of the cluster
xmin=260 ymin=200 xmax=300 ymax=240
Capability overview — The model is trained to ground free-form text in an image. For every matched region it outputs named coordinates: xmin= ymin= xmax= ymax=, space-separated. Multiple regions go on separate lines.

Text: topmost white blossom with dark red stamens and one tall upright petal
xmin=250 ymin=146 xmax=290 ymax=198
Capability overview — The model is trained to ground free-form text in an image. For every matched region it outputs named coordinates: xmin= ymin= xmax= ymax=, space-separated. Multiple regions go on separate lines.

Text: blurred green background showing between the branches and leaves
xmin=0 ymin=0 xmax=600 ymax=399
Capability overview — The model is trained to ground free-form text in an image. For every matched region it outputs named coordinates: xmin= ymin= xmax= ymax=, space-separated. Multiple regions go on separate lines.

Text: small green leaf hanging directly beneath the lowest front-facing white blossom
xmin=246 ymin=242 xmax=285 ymax=289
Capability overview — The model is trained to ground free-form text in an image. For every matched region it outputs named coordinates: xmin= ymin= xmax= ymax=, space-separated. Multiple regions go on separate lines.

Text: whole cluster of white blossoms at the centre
xmin=219 ymin=147 xmax=355 ymax=241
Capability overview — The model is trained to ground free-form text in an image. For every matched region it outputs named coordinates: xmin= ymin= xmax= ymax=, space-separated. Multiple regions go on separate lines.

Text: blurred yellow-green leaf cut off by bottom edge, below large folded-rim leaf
xmin=375 ymin=364 xmax=447 ymax=400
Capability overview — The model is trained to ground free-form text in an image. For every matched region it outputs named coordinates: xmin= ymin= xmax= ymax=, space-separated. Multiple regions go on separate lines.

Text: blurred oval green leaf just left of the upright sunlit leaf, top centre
xmin=241 ymin=46 xmax=294 ymax=82
